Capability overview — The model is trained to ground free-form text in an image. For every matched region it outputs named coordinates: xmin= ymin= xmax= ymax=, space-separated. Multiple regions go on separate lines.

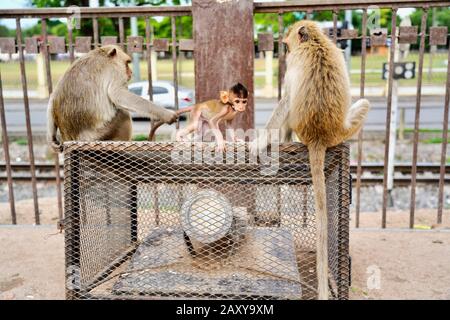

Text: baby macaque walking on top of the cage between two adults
xmin=149 ymin=83 xmax=248 ymax=150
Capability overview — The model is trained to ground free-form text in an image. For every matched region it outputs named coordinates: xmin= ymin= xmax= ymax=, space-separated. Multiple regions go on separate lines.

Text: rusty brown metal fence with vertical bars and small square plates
xmin=0 ymin=0 xmax=450 ymax=228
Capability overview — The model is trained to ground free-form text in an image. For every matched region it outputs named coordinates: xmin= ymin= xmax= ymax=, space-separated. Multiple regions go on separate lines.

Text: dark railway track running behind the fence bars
xmin=0 ymin=162 xmax=450 ymax=185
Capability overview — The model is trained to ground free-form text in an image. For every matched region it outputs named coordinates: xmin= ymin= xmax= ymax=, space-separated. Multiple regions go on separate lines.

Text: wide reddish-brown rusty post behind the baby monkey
xmin=192 ymin=0 xmax=255 ymax=130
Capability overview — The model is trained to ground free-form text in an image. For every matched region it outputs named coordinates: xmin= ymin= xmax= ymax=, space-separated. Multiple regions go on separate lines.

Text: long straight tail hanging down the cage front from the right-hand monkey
xmin=308 ymin=144 xmax=328 ymax=300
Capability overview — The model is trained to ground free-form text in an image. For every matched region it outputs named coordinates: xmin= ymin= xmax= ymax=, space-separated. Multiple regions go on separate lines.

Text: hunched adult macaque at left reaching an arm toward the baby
xmin=47 ymin=45 xmax=177 ymax=152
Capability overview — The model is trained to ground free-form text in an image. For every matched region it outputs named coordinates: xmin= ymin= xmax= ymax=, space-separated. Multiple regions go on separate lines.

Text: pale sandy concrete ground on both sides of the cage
xmin=0 ymin=225 xmax=450 ymax=300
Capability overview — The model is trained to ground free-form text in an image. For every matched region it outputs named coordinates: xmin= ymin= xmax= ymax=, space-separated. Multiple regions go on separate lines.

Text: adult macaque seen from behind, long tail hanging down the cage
xmin=252 ymin=20 xmax=370 ymax=300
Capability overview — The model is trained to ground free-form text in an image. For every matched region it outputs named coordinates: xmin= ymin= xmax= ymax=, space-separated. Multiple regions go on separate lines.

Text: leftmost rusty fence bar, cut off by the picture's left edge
xmin=0 ymin=70 xmax=17 ymax=224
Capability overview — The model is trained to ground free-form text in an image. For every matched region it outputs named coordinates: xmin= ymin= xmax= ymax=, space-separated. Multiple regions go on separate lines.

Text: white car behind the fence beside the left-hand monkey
xmin=128 ymin=81 xmax=195 ymax=118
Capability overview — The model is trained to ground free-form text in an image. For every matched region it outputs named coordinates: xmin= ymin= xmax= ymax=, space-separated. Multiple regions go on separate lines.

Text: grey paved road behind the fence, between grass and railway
xmin=0 ymin=96 xmax=450 ymax=135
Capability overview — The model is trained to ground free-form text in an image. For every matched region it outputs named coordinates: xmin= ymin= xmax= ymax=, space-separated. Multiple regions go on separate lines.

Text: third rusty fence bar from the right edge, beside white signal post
xmin=381 ymin=8 xmax=397 ymax=228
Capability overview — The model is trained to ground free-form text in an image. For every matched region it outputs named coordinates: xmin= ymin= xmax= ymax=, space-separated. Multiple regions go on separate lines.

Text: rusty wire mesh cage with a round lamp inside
xmin=64 ymin=142 xmax=350 ymax=299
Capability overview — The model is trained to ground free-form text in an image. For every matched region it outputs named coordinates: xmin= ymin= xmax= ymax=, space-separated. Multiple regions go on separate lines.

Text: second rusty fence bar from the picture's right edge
xmin=408 ymin=8 xmax=428 ymax=229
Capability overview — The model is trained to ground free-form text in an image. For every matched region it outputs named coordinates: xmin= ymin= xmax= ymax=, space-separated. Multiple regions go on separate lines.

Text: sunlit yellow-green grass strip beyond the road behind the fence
xmin=0 ymin=53 xmax=447 ymax=90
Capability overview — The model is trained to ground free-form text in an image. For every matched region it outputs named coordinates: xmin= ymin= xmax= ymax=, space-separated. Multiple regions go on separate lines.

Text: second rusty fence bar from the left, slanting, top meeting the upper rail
xmin=16 ymin=18 xmax=40 ymax=225
